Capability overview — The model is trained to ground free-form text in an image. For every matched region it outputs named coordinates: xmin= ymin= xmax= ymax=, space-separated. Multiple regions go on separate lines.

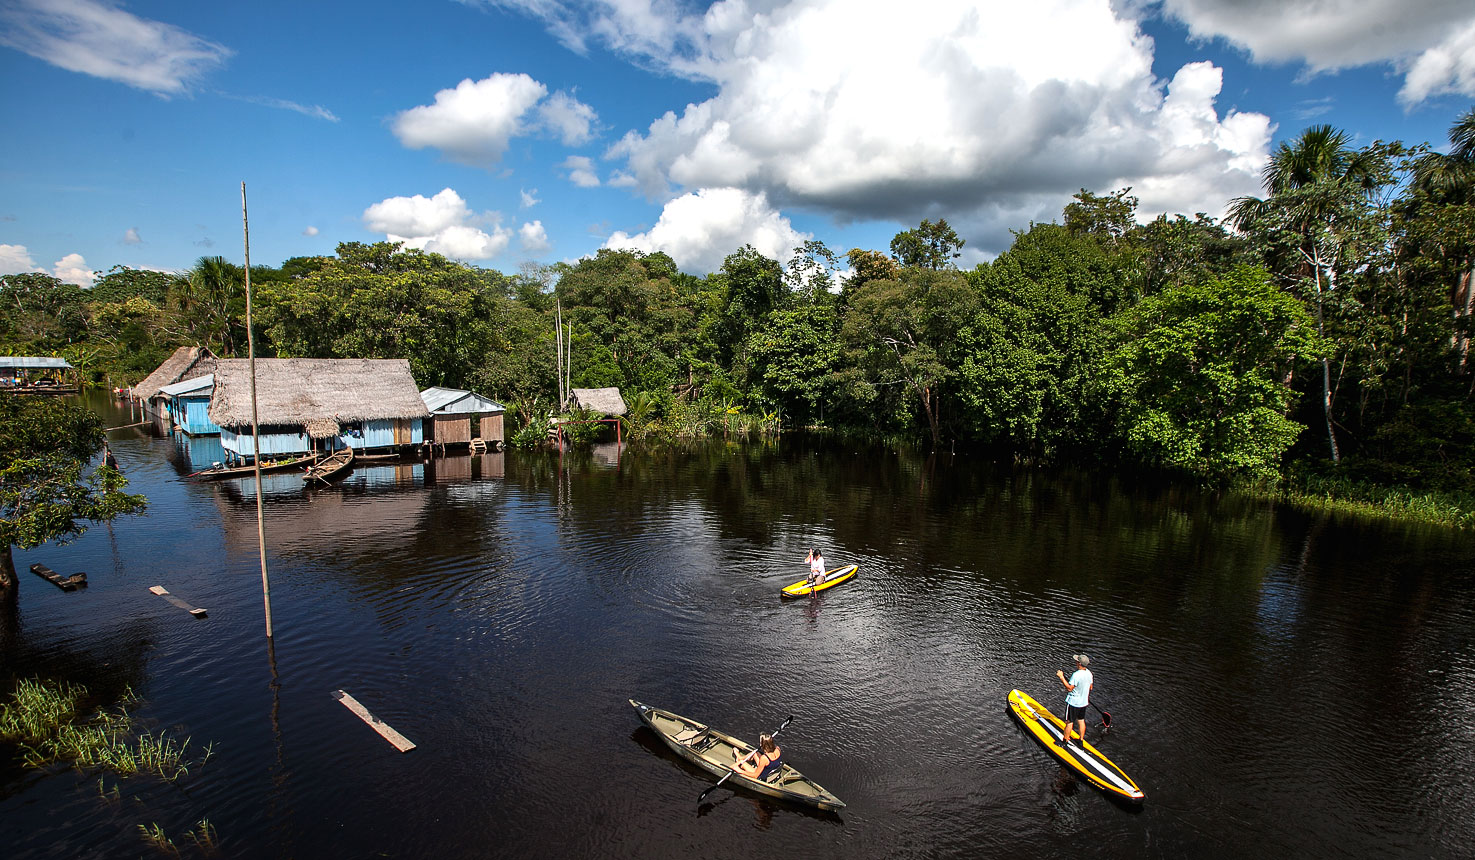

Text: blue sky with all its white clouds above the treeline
xmin=0 ymin=0 xmax=1475 ymax=286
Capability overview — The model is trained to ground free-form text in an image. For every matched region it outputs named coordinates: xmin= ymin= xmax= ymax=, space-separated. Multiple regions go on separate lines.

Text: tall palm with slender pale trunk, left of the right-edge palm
xmin=1229 ymin=125 xmax=1384 ymax=463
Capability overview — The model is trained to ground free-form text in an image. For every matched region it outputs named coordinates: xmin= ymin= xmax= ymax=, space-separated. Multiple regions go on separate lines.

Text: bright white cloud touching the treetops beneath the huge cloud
xmin=605 ymin=187 xmax=814 ymax=273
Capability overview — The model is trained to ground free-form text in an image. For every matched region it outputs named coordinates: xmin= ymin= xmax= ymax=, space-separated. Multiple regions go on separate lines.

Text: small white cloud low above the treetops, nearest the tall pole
xmin=363 ymin=189 xmax=512 ymax=260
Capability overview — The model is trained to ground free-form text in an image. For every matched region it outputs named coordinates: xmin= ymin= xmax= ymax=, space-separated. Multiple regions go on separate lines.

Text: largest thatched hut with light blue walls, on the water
xmin=209 ymin=358 xmax=431 ymax=462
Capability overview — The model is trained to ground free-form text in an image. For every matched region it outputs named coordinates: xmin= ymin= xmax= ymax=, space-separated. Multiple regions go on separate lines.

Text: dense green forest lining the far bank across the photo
xmin=0 ymin=109 xmax=1475 ymax=512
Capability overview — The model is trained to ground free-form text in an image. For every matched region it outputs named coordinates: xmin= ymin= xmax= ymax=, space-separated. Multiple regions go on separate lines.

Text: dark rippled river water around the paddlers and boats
xmin=0 ymin=400 xmax=1475 ymax=860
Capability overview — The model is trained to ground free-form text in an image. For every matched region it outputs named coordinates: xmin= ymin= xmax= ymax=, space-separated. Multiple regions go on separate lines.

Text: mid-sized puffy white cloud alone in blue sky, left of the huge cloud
xmin=392 ymin=72 xmax=596 ymax=167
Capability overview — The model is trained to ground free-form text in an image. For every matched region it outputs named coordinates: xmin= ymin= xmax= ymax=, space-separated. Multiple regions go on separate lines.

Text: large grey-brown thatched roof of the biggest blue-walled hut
xmin=209 ymin=358 xmax=431 ymax=438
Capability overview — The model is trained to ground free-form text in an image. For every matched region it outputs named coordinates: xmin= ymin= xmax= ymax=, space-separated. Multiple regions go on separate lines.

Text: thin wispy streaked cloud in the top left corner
xmin=0 ymin=0 xmax=233 ymax=96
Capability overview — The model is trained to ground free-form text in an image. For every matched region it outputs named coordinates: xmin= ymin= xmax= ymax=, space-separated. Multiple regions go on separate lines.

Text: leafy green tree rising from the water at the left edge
xmin=0 ymin=394 xmax=148 ymax=603
